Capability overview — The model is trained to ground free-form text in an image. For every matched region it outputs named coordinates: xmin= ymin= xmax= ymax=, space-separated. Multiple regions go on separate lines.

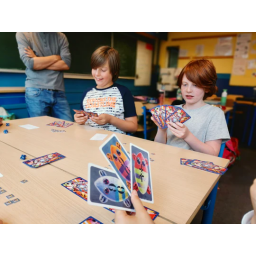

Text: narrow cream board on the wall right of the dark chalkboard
xmin=134 ymin=40 xmax=153 ymax=86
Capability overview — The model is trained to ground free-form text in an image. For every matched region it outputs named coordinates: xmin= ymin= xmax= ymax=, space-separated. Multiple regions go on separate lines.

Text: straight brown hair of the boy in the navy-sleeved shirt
xmin=91 ymin=46 xmax=120 ymax=82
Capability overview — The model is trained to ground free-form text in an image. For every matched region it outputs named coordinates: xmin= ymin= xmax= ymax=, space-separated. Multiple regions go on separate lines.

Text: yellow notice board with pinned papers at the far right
xmin=230 ymin=33 xmax=256 ymax=86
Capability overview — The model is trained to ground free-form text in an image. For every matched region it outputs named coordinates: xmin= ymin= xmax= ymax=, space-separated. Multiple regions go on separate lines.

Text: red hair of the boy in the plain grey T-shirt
xmin=178 ymin=59 xmax=218 ymax=100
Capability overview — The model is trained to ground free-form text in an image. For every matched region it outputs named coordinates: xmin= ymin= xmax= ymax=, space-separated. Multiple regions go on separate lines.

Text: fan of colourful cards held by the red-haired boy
xmin=150 ymin=105 xmax=191 ymax=129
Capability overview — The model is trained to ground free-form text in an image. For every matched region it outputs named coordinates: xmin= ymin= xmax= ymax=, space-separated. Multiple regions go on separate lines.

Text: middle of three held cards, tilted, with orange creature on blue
xmin=100 ymin=134 xmax=131 ymax=194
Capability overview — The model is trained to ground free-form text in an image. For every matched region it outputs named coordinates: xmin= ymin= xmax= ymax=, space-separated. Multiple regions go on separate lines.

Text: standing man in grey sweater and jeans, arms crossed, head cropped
xmin=16 ymin=32 xmax=72 ymax=121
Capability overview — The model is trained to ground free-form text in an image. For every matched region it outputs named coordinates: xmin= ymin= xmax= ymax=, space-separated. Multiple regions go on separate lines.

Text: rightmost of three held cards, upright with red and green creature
xmin=130 ymin=143 xmax=154 ymax=203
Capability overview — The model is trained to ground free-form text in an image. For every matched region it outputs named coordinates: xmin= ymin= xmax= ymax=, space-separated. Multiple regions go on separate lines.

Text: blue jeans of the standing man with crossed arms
xmin=25 ymin=87 xmax=73 ymax=121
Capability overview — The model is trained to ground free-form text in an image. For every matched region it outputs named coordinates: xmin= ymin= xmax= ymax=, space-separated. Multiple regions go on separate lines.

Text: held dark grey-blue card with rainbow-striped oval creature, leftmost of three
xmin=88 ymin=164 xmax=135 ymax=212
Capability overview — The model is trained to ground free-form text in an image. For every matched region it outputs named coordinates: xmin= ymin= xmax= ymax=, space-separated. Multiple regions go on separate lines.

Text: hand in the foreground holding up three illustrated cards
xmin=115 ymin=190 xmax=154 ymax=224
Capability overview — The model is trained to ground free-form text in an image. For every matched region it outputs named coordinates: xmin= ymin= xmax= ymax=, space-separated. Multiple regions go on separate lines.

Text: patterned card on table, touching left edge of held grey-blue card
xmin=61 ymin=177 xmax=88 ymax=201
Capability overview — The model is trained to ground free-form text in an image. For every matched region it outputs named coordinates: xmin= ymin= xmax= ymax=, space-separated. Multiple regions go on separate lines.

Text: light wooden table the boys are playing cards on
xmin=0 ymin=117 xmax=229 ymax=223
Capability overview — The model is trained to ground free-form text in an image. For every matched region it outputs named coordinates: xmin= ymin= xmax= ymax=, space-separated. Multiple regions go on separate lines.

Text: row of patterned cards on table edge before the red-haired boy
xmin=180 ymin=158 xmax=227 ymax=175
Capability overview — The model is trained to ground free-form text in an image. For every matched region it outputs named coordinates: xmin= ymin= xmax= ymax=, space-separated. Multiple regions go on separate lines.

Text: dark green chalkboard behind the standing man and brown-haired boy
xmin=0 ymin=32 xmax=137 ymax=77
